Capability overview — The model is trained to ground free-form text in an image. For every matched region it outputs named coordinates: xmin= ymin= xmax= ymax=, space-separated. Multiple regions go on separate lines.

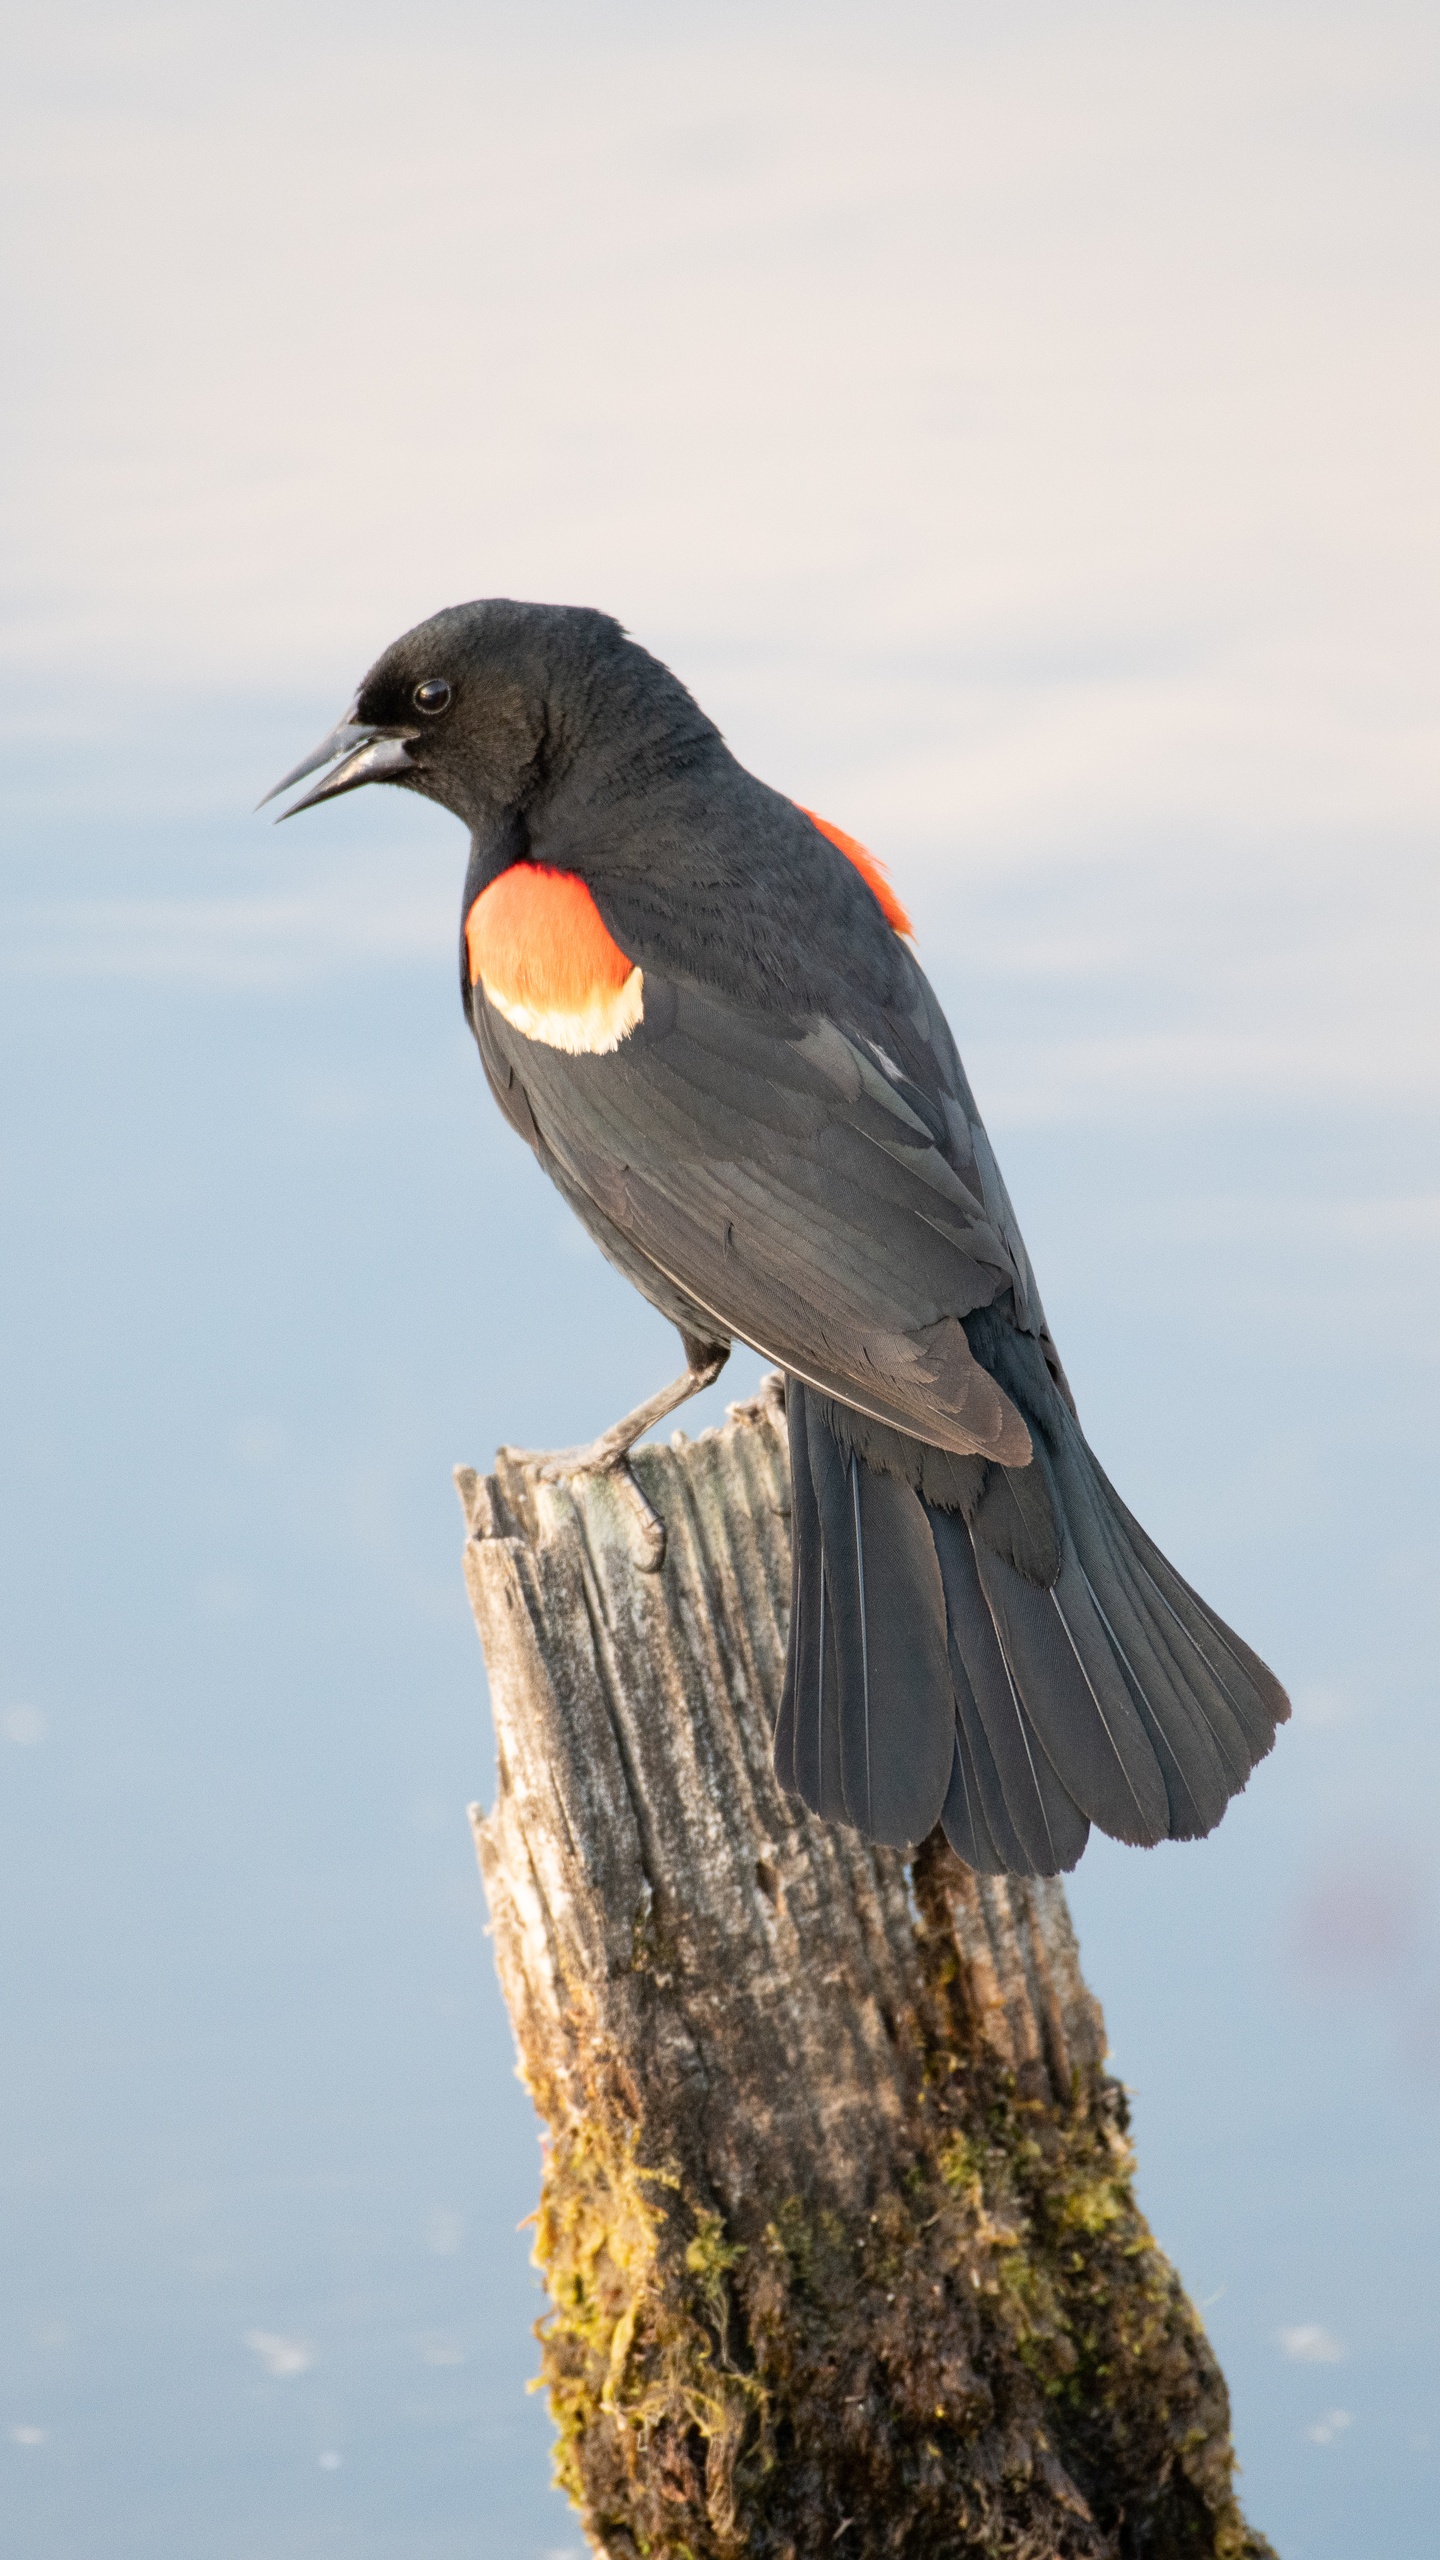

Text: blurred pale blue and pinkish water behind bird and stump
xmin=0 ymin=0 xmax=1440 ymax=2560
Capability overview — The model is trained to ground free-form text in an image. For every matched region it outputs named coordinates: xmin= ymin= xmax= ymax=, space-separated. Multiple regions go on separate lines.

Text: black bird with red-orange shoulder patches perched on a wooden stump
xmin=261 ymin=596 xmax=1289 ymax=1876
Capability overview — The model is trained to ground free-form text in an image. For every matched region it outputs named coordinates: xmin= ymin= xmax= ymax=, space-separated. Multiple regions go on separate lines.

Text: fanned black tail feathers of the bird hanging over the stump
xmin=774 ymin=1380 xmax=1289 ymax=1876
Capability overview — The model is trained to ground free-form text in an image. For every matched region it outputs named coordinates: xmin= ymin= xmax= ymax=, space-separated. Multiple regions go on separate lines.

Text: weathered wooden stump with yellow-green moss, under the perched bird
xmin=456 ymin=1380 xmax=1273 ymax=2560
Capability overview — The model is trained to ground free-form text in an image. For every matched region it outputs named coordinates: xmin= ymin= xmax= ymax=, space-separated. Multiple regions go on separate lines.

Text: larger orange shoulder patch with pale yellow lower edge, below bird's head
xmin=464 ymin=863 xmax=646 ymax=1057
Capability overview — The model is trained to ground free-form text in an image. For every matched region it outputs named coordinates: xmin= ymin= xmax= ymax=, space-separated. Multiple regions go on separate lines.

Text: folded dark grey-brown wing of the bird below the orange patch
xmin=474 ymin=970 xmax=1033 ymax=1467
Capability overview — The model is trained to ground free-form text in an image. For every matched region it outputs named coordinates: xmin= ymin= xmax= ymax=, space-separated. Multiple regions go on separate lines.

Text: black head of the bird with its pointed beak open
xmin=261 ymin=596 xmax=710 ymax=832
